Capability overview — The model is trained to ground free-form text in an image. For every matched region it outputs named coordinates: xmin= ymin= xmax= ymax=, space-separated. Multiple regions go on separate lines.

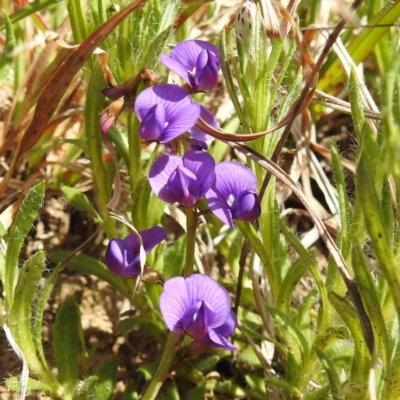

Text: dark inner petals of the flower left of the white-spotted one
xmin=162 ymin=167 xmax=199 ymax=207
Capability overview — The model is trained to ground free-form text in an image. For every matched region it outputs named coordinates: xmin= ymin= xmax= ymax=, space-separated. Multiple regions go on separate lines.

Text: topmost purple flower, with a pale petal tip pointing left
xmin=160 ymin=40 xmax=220 ymax=91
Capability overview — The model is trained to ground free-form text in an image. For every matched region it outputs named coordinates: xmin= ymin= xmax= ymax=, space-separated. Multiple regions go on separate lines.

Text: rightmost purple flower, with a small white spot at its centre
xmin=206 ymin=161 xmax=261 ymax=228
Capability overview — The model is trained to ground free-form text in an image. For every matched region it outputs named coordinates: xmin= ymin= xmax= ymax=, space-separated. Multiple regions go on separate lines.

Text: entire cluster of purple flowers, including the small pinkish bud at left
xmin=102 ymin=40 xmax=261 ymax=353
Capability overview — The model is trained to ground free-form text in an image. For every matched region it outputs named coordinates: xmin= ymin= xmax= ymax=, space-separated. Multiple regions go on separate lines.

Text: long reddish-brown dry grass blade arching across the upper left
xmin=0 ymin=0 xmax=147 ymax=196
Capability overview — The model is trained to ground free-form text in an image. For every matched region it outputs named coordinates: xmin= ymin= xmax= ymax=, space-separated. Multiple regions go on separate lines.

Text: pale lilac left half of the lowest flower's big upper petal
xmin=160 ymin=276 xmax=190 ymax=333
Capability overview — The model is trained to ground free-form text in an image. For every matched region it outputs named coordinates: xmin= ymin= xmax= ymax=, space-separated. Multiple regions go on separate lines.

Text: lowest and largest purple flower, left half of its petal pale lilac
xmin=160 ymin=274 xmax=237 ymax=350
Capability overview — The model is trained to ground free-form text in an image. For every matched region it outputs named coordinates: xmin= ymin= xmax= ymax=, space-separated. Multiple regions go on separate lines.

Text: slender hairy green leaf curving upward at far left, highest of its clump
xmin=4 ymin=182 xmax=45 ymax=309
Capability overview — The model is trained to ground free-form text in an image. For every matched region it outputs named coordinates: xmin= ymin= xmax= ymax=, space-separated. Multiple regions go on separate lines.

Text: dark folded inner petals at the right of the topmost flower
xmin=194 ymin=50 xmax=219 ymax=90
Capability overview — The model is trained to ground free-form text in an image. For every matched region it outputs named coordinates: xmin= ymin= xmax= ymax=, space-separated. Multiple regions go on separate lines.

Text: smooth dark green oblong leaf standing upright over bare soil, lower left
xmin=53 ymin=296 xmax=81 ymax=394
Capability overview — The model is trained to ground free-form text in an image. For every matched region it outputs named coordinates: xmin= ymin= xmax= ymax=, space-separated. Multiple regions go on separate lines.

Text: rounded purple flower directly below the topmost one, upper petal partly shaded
xmin=134 ymin=85 xmax=200 ymax=143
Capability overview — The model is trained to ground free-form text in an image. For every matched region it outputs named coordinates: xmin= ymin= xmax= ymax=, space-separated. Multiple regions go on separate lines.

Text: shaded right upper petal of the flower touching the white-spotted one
xmin=183 ymin=151 xmax=215 ymax=197
